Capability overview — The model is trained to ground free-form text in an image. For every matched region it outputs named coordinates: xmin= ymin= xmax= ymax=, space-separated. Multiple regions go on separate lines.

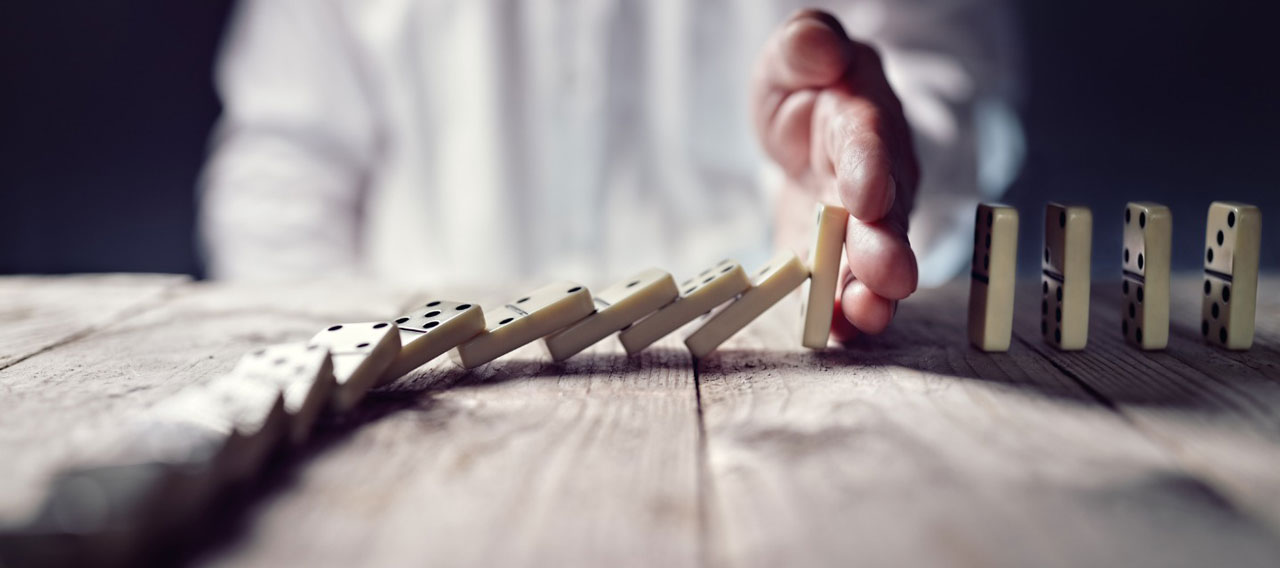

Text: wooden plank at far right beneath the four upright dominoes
xmin=1016 ymin=275 xmax=1280 ymax=532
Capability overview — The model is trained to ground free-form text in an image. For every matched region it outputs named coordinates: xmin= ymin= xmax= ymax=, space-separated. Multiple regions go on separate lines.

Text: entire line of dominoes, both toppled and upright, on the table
xmin=0 ymin=202 xmax=1261 ymax=565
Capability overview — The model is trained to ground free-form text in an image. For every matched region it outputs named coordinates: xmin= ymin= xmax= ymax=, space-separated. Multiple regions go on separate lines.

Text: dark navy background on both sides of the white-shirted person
xmin=0 ymin=0 xmax=1280 ymax=276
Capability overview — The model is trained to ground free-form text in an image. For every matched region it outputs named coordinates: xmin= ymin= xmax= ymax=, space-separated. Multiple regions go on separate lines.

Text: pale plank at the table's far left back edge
xmin=0 ymin=274 xmax=188 ymax=368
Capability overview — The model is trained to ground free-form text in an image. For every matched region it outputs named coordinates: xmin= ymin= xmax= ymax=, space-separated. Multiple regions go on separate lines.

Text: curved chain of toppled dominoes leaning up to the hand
xmin=0 ymin=205 xmax=849 ymax=565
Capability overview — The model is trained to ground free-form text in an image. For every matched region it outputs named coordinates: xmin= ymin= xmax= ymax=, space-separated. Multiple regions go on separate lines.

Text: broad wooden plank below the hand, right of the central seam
xmin=699 ymin=283 xmax=1280 ymax=565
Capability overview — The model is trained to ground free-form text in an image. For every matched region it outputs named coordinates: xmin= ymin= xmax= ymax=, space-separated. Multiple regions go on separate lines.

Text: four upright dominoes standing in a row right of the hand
xmin=969 ymin=202 xmax=1262 ymax=352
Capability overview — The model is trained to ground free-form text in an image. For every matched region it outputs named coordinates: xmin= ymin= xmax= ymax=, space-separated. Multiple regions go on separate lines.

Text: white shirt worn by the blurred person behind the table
xmin=200 ymin=0 xmax=1020 ymax=285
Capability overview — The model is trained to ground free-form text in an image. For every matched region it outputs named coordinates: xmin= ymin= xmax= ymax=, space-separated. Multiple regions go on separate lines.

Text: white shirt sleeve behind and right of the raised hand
xmin=826 ymin=0 xmax=1024 ymax=287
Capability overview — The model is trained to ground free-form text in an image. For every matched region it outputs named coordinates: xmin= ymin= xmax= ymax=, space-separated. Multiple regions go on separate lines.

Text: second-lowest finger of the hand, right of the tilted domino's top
xmin=845 ymin=210 xmax=918 ymax=299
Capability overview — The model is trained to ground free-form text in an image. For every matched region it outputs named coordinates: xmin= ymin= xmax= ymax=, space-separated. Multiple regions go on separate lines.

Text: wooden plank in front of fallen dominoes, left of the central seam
xmin=200 ymin=308 xmax=699 ymax=567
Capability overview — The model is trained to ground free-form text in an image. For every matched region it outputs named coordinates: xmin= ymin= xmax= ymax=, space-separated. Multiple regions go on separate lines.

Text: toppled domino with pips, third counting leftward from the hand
xmin=618 ymin=258 xmax=751 ymax=354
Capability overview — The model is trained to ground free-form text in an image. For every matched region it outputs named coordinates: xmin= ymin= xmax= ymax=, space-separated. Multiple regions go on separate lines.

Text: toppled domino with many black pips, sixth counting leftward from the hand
xmin=379 ymin=299 xmax=484 ymax=385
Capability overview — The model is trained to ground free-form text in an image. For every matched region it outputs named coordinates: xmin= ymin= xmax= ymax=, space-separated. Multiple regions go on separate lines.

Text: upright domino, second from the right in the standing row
xmin=1120 ymin=201 xmax=1174 ymax=349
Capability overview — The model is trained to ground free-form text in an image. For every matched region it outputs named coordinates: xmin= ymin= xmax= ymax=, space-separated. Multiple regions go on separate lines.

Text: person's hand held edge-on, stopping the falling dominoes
xmin=753 ymin=10 xmax=920 ymax=340
